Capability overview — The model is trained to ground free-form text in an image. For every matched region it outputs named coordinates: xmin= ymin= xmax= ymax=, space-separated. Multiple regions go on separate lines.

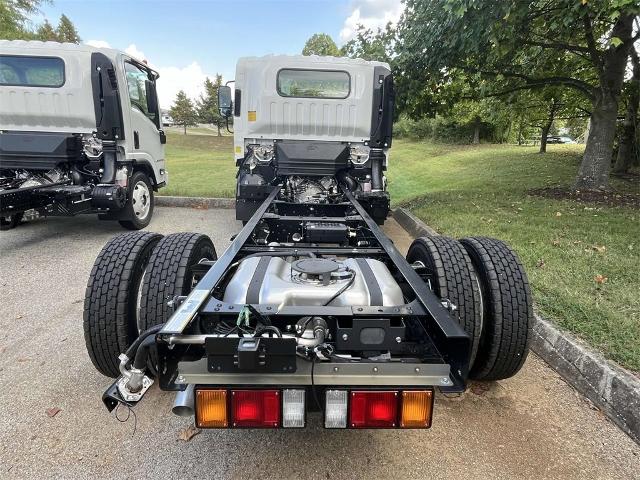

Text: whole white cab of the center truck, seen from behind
xmin=219 ymin=55 xmax=394 ymax=223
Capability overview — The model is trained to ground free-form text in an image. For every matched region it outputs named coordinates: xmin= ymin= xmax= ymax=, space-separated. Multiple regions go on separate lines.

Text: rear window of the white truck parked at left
xmin=0 ymin=55 xmax=64 ymax=88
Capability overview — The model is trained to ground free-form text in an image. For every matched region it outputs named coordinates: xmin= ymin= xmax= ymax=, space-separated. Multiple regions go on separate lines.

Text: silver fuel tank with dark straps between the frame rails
xmin=224 ymin=256 xmax=404 ymax=306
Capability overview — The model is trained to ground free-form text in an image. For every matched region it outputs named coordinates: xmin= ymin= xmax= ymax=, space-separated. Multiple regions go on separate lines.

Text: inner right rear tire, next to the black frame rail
xmin=407 ymin=236 xmax=482 ymax=364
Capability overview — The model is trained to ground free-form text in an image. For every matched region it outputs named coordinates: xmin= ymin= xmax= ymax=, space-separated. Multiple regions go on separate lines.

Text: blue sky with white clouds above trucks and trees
xmin=33 ymin=0 xmax=403 ymax=108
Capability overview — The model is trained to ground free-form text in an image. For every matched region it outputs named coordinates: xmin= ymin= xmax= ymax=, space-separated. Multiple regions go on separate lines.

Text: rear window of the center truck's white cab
xmin=277 ymin=69 xmax=351 ymax=98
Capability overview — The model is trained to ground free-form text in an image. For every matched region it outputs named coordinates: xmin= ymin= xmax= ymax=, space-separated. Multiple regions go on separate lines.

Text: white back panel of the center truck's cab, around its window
xmin=234 ymin=56 xmax=384 ymax=158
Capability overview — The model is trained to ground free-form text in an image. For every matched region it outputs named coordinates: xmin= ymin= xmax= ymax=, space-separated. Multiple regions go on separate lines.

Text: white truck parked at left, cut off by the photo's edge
xmin=0 ymin=41 xmax=167 ymax=229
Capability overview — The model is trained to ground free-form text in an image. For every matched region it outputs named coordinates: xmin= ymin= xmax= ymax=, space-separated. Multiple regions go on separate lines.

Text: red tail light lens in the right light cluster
xmin=349 ymin=391 xmax=398 ymax=428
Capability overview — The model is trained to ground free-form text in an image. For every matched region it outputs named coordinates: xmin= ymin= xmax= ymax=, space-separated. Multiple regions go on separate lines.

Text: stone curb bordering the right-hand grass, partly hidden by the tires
xmin=393 ymin=204 xmax=640 ymax=444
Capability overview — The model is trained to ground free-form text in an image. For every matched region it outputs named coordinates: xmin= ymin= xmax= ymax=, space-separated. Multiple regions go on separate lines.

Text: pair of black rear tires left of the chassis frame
xmin=83 ymin=231 xmax=217 ymax=378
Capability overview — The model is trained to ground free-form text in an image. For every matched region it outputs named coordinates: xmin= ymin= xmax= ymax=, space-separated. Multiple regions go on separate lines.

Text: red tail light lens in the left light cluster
xmin=231 ymin=390 xmax=280 ymax=428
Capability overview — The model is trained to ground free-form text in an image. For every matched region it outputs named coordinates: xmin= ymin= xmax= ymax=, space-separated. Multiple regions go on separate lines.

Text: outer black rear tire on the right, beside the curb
xmin=460 ymin=237 xmax=533 ymax=380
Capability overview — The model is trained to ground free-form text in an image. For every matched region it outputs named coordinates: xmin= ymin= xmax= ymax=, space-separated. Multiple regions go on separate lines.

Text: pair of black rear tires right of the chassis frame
xmin=407 ymin=236 xmax=533 ymax=380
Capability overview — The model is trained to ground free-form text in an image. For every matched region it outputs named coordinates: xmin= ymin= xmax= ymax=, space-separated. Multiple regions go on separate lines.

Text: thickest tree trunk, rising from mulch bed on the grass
xmin=576 ymin=92 xmax=618 ymax=190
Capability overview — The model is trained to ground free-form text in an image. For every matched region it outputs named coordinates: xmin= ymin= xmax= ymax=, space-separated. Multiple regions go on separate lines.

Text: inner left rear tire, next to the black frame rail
xmin=138 ymin=233 xmax=218 ymax=331
